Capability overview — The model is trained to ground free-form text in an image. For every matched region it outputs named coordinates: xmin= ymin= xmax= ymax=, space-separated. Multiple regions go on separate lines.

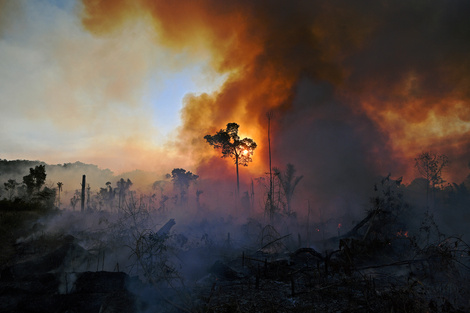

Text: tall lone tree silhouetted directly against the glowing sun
xmin=204 ymin=123 xmax=257 ymax=197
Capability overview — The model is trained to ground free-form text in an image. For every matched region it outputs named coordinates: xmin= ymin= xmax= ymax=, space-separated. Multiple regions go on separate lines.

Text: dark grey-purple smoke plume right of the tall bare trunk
xmin=274 ymin=79 xmax=398 ymax=213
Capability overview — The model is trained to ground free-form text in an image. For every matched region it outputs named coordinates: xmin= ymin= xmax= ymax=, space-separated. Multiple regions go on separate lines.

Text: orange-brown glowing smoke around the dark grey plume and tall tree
xmin=82 ymin=0 xmax=470 ymax=182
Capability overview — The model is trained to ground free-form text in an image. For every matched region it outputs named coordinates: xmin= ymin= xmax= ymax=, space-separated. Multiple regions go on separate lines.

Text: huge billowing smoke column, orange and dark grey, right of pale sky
xmin=82 ymin=0 xmax=470 ymax=212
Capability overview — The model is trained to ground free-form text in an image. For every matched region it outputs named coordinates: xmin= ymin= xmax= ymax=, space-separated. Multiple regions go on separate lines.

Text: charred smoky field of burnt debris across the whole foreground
xmin=0 ymin=171 xmax=470 ymax=313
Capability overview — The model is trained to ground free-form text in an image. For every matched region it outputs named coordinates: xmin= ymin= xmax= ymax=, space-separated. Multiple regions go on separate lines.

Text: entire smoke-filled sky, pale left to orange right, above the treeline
xmin=0 ymin=0 xmax=470 ymax=213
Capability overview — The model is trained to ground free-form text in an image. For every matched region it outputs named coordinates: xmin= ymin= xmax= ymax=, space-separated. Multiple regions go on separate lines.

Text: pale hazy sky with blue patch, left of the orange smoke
xmin=0 ymin=0 xmax=224 ymax=172
